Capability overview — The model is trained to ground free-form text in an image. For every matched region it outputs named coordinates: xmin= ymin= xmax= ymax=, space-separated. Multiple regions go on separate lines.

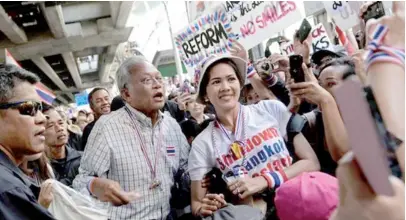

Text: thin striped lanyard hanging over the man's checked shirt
xmin=125 ymin=106 xmax=162 ymax=181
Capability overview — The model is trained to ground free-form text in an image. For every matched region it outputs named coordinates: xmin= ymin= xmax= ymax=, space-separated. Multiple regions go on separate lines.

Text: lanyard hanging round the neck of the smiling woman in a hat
xmin=211 ymin=105 xmax=247 ymax=170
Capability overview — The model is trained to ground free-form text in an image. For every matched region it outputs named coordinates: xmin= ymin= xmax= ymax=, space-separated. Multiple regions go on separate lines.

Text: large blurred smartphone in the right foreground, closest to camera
xmin=333 ymin=78 xmax=396 ymax=196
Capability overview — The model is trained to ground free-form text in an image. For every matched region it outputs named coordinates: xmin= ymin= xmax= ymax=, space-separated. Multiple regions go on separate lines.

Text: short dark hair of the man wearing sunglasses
xmin=0 ymin=64 xmax=40 ymax=103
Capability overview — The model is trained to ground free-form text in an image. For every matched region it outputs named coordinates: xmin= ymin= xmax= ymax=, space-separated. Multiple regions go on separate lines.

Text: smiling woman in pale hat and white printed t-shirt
xmin=188 ymin=55 xmax=320 ymax=216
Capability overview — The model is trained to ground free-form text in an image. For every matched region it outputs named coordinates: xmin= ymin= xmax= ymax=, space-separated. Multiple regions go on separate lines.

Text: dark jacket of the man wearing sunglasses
xmin=0 ymin=150 xmax=54 ymax=220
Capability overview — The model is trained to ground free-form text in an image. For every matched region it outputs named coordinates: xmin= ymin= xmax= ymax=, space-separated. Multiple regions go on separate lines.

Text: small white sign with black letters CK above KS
xmin=310 ymin=23 xmax=334 ymax=54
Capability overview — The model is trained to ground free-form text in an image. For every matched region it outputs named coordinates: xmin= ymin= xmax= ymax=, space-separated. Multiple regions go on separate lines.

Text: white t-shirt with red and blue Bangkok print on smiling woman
xmin=188 ymin=100 xmax=292 ymax=181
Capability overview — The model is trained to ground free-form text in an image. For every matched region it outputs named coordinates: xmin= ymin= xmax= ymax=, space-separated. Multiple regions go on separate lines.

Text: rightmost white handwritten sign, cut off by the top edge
xmin=323 ymin=1 xmax=363 ymax=31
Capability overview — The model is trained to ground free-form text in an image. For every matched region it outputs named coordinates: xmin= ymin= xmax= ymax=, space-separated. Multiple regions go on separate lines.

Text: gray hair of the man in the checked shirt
xmin=116 ymin=56 xmax=148 ymax=91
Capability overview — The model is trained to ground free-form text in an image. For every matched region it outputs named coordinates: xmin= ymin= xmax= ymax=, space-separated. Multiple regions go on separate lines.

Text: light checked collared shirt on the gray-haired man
xmin=73 ymin=104 xmax=190 ymax=220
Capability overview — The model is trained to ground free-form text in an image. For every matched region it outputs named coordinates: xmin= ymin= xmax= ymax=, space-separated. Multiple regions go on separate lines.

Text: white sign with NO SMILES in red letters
xmin=231 ymin=1 xmax=303 ymax=49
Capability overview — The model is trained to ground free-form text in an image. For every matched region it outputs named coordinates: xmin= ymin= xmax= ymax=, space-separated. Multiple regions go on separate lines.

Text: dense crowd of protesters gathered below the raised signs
xmin=0 ymin=2 xmax=405 ymax=220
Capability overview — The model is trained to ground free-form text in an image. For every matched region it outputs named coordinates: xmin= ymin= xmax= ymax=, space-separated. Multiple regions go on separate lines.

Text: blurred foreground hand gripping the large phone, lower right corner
xmin=330 ymin=152 xmax=405 ymax=220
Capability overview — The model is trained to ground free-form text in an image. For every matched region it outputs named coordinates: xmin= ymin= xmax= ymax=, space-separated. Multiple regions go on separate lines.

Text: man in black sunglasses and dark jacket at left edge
xmin=0 ymin=64 xmax=54 ymax=220
